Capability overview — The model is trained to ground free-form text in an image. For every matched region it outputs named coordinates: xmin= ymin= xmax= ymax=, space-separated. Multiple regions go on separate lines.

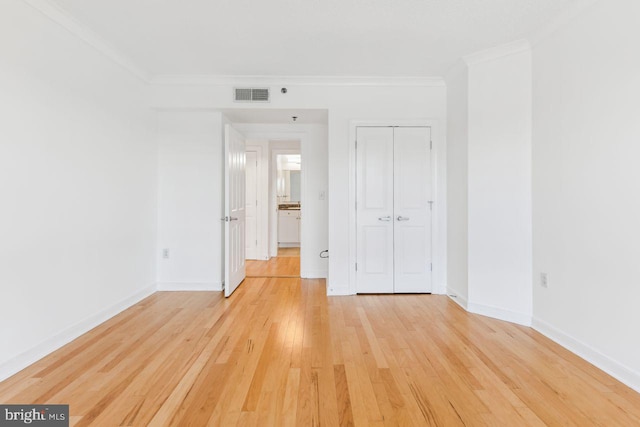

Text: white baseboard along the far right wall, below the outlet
xmin=532 ymin=317 xmax=640 ymax=393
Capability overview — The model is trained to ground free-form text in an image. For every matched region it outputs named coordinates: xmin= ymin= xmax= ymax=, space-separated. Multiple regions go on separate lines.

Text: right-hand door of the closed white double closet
xmin=393 ymin=127 xmax=432 ymax=293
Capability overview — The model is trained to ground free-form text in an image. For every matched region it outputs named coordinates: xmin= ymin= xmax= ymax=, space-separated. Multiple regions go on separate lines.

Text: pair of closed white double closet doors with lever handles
xmin=356 ymin=127 xmax=432 ymax=293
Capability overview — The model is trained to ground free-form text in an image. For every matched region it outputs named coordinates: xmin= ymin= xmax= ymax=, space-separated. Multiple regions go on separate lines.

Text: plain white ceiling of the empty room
xmin=52 ymin=0 xmax=585 ymax=76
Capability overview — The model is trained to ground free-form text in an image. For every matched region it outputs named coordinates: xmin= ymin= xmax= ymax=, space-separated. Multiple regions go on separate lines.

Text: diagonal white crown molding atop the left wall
xmin=23 ymin=0 xmax=150 ymax=83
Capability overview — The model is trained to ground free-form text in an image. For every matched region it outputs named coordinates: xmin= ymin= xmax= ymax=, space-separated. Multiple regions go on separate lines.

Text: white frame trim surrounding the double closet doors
xmin=348 ymin=119 xmax=446 ymax=295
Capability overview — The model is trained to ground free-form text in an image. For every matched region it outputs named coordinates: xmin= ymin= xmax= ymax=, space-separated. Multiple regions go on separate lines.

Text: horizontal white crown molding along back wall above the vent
xmin=149 ymin=74 xmax=445 ymax=87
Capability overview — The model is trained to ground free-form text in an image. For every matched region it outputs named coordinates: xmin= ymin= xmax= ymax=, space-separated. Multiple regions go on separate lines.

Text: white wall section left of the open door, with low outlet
xmin=156 ymin=111 xmax=224 ymax=290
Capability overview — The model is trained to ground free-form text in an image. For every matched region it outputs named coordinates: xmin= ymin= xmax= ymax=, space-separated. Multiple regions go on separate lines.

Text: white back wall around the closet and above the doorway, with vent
xmin=152 ymin=83 xmax=446 ymax=294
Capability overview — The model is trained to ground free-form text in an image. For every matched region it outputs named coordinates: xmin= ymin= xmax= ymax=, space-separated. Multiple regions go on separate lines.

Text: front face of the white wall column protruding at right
xmin=467 ymin=44 xmax=532 ymax=324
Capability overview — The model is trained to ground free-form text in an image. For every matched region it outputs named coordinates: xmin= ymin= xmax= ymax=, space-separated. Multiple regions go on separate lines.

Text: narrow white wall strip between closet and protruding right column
xmin=446 ymin=63 xmax=469 ymax=308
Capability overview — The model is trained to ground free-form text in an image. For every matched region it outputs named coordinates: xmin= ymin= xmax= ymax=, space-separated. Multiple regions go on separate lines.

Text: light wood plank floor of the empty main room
xmin=0 ymin=278 xmax=640 ymax=426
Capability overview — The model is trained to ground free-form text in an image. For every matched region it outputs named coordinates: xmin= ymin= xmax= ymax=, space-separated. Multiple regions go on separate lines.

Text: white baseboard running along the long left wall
xmin=0 ymin=286 xmax=156 ymax=381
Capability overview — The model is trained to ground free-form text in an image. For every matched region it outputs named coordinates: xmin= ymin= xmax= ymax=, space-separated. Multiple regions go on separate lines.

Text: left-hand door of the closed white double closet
xmin=356 ymin=127 xmax=394 ymax=293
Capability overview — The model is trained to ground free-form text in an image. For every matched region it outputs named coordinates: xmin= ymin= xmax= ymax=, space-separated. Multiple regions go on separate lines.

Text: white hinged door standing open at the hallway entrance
xmin=224 ymin=125 xmax=246 ymax=297
